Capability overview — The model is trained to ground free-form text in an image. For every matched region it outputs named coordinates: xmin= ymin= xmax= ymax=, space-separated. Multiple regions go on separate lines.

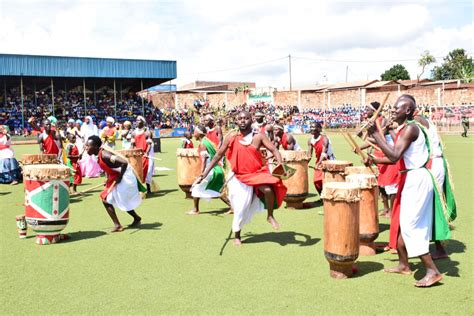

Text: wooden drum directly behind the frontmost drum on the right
xmin=346 ymin=174 xmax=379 ymax=256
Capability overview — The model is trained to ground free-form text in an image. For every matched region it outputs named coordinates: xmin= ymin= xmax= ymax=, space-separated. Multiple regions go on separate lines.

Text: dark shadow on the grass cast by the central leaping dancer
xmin=242 ymin=232 xmax=321 ymax=247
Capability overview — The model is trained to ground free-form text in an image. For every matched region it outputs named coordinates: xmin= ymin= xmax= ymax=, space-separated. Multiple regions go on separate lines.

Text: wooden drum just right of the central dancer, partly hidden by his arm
xmin=280 ymin=150 xmax=311 ymax=208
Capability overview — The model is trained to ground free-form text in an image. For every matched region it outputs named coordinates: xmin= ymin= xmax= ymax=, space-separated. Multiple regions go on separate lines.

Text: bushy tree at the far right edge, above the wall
xmin=431 ymin=48 xmax=474 ymax=82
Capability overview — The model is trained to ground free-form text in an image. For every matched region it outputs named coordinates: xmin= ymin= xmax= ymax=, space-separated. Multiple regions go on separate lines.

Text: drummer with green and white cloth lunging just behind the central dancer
xmin=186 ymin=125 xmax=225 ymax=215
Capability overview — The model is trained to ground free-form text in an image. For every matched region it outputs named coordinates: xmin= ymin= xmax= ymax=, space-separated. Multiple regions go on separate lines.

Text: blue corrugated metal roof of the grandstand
xmin=0 ymin=54 xmax=176 ymax=80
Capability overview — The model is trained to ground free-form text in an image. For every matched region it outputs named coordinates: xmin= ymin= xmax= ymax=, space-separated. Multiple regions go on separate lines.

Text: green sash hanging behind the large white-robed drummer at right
xmin=409 ymin=121 xmax=454 ymax=240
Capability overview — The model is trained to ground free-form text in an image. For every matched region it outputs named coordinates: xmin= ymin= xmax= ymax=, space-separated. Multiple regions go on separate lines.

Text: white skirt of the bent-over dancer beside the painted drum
xmin=106 ymin=165 xmax=142 ymax=212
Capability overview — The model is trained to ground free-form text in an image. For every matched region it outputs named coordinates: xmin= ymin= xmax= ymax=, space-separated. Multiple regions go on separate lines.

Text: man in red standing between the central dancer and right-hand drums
xmin=308 ymin=122 xmax=336 ymax=195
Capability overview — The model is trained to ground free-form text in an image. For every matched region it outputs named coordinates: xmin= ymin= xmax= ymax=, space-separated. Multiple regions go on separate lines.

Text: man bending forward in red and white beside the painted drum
xmin=86 ymin=136 xmax=142 ymax=233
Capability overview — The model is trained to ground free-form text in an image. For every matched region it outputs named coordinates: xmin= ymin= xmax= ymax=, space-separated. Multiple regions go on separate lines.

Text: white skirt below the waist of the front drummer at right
xmin=400 ymin=168 xmax=433 ymax=257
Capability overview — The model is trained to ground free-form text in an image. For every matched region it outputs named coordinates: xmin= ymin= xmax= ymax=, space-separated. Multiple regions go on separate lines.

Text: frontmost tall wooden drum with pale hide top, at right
xmin=321 ymin=182 xmax=360 ymax=279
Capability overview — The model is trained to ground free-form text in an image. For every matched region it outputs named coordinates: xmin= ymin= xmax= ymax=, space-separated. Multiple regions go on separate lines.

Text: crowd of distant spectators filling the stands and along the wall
xmin=0 ymin=87 xmax=474 ymax=135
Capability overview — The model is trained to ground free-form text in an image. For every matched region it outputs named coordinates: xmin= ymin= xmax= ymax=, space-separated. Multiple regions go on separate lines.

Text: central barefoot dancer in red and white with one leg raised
xmin=196 ymin=111 xmax=287 ymax=245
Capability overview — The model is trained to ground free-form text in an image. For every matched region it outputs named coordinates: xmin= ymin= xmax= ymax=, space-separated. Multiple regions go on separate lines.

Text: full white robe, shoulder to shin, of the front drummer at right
xmin=400 ymin=130 xmax=433 ymax=257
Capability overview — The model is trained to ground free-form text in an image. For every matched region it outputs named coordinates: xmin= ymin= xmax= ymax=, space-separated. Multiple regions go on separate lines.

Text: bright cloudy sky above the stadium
xmin=0 ymin=0 xmax=474 ymax=88
